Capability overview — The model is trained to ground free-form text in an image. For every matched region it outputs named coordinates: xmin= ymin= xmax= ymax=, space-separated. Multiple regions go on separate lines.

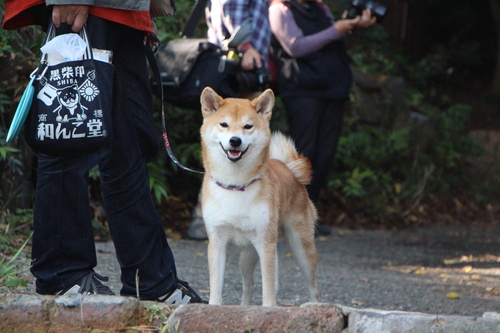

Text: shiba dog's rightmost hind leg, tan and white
xmin=285 ymin=220 xmax=318 ymax=302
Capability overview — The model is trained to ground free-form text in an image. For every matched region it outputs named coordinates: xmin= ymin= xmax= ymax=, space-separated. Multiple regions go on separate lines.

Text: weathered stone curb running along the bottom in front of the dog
xmin=0 ymin=294 xmax=500 ymax=333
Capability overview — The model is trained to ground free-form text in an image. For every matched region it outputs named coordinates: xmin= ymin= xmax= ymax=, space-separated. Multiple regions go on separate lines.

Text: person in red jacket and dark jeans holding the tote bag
xmin=3 ymin=0 xmax=202 ymax=303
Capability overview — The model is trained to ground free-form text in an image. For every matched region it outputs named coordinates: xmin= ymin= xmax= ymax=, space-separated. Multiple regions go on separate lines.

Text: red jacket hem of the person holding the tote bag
xmin=2 ymin=0 xmax=151 ymax=32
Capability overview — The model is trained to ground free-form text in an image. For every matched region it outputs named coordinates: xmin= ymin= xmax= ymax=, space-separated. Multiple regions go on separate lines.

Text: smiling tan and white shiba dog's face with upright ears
xmin=200 ymin=87 xmax=274 ymax=163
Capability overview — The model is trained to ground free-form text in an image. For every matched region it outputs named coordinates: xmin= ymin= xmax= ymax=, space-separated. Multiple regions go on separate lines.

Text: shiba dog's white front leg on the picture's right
xmin=257 ymin=242 xmax=278 ymax=306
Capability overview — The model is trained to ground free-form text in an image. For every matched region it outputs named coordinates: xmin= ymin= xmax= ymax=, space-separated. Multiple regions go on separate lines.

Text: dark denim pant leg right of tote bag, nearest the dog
xmin=92 ymin=18 xmax=177 ymax=299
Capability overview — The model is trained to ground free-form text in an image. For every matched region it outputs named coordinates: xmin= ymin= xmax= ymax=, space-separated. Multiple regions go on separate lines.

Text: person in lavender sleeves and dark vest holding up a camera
xmin=269 ymin=0 xmax=376 ymax=234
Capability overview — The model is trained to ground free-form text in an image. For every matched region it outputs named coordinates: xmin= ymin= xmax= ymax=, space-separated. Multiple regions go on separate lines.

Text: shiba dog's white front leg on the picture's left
xmin=208 ymin=238 xmax=227 ymax=305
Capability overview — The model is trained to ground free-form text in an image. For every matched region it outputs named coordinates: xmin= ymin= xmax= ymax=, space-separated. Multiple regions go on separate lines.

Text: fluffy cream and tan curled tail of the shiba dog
xmin=270 ymin=132 xmax=312 ymax=185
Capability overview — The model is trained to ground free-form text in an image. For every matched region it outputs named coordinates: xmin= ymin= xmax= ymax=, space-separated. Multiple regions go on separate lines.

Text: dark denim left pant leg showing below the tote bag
xmin=31 ymin=154 xmax=97 ymax=294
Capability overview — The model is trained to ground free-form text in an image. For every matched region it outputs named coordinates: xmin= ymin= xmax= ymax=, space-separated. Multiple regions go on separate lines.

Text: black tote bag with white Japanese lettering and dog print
xmin=25 ymin=24 xmax=114 ymax=156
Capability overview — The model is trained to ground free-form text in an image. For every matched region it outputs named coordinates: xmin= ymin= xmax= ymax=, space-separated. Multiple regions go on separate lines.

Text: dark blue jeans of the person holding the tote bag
xmin=31 ymin=16 xmax=178 ymax=299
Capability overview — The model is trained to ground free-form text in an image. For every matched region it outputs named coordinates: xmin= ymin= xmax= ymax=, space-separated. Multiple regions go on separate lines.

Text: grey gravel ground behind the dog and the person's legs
xmin=90 ymin=226 xmax=500 ymax=316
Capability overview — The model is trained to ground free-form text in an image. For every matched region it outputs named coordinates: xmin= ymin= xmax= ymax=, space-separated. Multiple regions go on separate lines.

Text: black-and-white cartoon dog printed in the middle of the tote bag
xmin=56 ymin=84 xmax=87 ymax=123
